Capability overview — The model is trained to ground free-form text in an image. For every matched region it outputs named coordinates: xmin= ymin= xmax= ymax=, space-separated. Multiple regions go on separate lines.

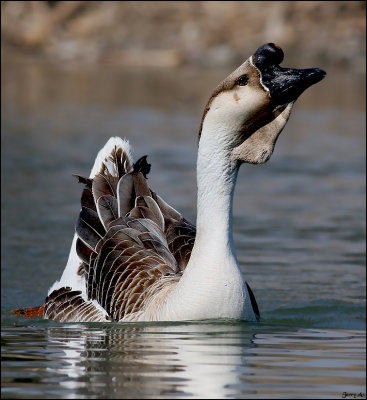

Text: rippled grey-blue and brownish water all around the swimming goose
xmin=1 ymin=64 xmax=366 ymax=398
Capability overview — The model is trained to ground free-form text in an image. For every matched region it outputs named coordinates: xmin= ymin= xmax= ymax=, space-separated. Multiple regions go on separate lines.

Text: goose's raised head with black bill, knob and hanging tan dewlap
xmin=199 ymin=43 xmax=326 ymax=165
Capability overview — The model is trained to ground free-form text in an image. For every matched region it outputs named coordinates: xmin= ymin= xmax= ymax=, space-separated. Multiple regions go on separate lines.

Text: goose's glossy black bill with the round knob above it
xmin=252 ymin=43 xmax=326 ymax=105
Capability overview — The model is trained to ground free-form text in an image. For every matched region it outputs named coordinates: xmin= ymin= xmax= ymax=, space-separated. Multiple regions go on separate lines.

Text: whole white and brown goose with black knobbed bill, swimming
xmin=31 ymin=43 xmax=325 ymax=322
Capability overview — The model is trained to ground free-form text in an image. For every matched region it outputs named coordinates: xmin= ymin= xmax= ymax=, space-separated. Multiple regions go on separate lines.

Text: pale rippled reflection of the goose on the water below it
xmin=48 ymin=321 xmax=253 ymax=398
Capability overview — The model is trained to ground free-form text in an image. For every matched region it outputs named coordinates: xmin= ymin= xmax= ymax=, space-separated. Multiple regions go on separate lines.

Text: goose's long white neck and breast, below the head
xmin=160 ymin=119 xmax=254 ymax=319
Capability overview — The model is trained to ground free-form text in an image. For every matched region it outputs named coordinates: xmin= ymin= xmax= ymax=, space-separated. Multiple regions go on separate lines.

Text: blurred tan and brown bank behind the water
xmin=2 ymin=1 xmax=366 ymax=72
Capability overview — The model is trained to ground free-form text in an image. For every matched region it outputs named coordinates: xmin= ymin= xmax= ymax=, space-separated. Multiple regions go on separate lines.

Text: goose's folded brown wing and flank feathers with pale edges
xmin=45 ymin=145 xmax=195 ymax=321
